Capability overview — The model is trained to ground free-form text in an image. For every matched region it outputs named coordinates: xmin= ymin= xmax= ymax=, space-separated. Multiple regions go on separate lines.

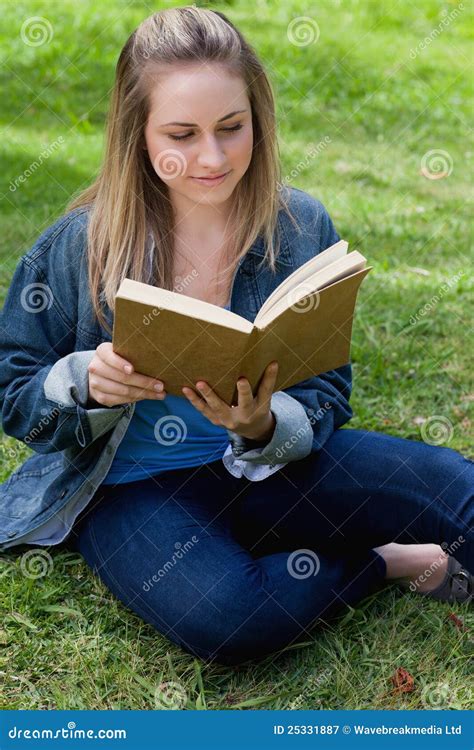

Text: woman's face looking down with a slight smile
xmin=145 ymin=64 xmax=253 ymax=210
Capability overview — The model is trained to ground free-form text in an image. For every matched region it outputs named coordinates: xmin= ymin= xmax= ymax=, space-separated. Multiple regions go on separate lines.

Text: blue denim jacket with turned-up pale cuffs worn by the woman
xmin=0 ymin=188 xmax=352 ymax=549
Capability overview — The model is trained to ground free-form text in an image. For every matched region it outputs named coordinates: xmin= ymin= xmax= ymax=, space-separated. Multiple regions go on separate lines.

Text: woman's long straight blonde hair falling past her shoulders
xmin=66 ymin=5 xmax=291 ymax=331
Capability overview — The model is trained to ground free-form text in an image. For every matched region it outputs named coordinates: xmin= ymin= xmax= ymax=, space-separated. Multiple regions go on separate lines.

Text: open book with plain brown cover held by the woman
xmin=112 ymin=240 xmax=372 ymax=405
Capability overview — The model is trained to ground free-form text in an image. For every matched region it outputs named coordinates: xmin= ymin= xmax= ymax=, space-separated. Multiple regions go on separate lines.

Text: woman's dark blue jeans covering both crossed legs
xmin=68 ymin=428 xmax=474 ymax=665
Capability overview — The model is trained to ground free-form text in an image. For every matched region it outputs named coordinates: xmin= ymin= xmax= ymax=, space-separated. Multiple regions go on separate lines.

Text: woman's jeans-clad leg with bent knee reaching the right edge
xmin=231 ymin=429 xmax=474 ymax=572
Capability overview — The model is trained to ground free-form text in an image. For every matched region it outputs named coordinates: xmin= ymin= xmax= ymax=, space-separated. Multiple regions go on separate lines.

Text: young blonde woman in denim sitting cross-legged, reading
xmin=0 ymin=6 xmax=474 ymax=664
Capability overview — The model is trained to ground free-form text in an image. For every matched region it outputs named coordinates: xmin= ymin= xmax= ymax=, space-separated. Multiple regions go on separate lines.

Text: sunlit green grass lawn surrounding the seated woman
xmin=0 ymin=0 xmax=473 ymax=710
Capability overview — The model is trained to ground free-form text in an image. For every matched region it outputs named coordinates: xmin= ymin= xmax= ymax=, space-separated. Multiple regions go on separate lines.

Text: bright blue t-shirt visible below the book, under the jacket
xmin=102 ymin=305 xmax=230 ymax=484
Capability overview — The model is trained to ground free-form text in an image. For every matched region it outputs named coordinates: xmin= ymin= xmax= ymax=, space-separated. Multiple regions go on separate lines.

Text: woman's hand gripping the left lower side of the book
xmin=87 ymin=341 xmax=166 ymax=406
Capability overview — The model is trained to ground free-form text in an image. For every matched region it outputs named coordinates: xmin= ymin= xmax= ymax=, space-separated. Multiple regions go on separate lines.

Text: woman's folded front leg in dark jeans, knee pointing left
xmin=71 ymin=460 xmax=385 ymax=664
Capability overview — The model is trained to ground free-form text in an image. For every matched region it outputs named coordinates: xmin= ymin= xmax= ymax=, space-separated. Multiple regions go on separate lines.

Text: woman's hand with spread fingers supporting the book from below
xmin=182 ymin=362 xmax=278 ymax=442
